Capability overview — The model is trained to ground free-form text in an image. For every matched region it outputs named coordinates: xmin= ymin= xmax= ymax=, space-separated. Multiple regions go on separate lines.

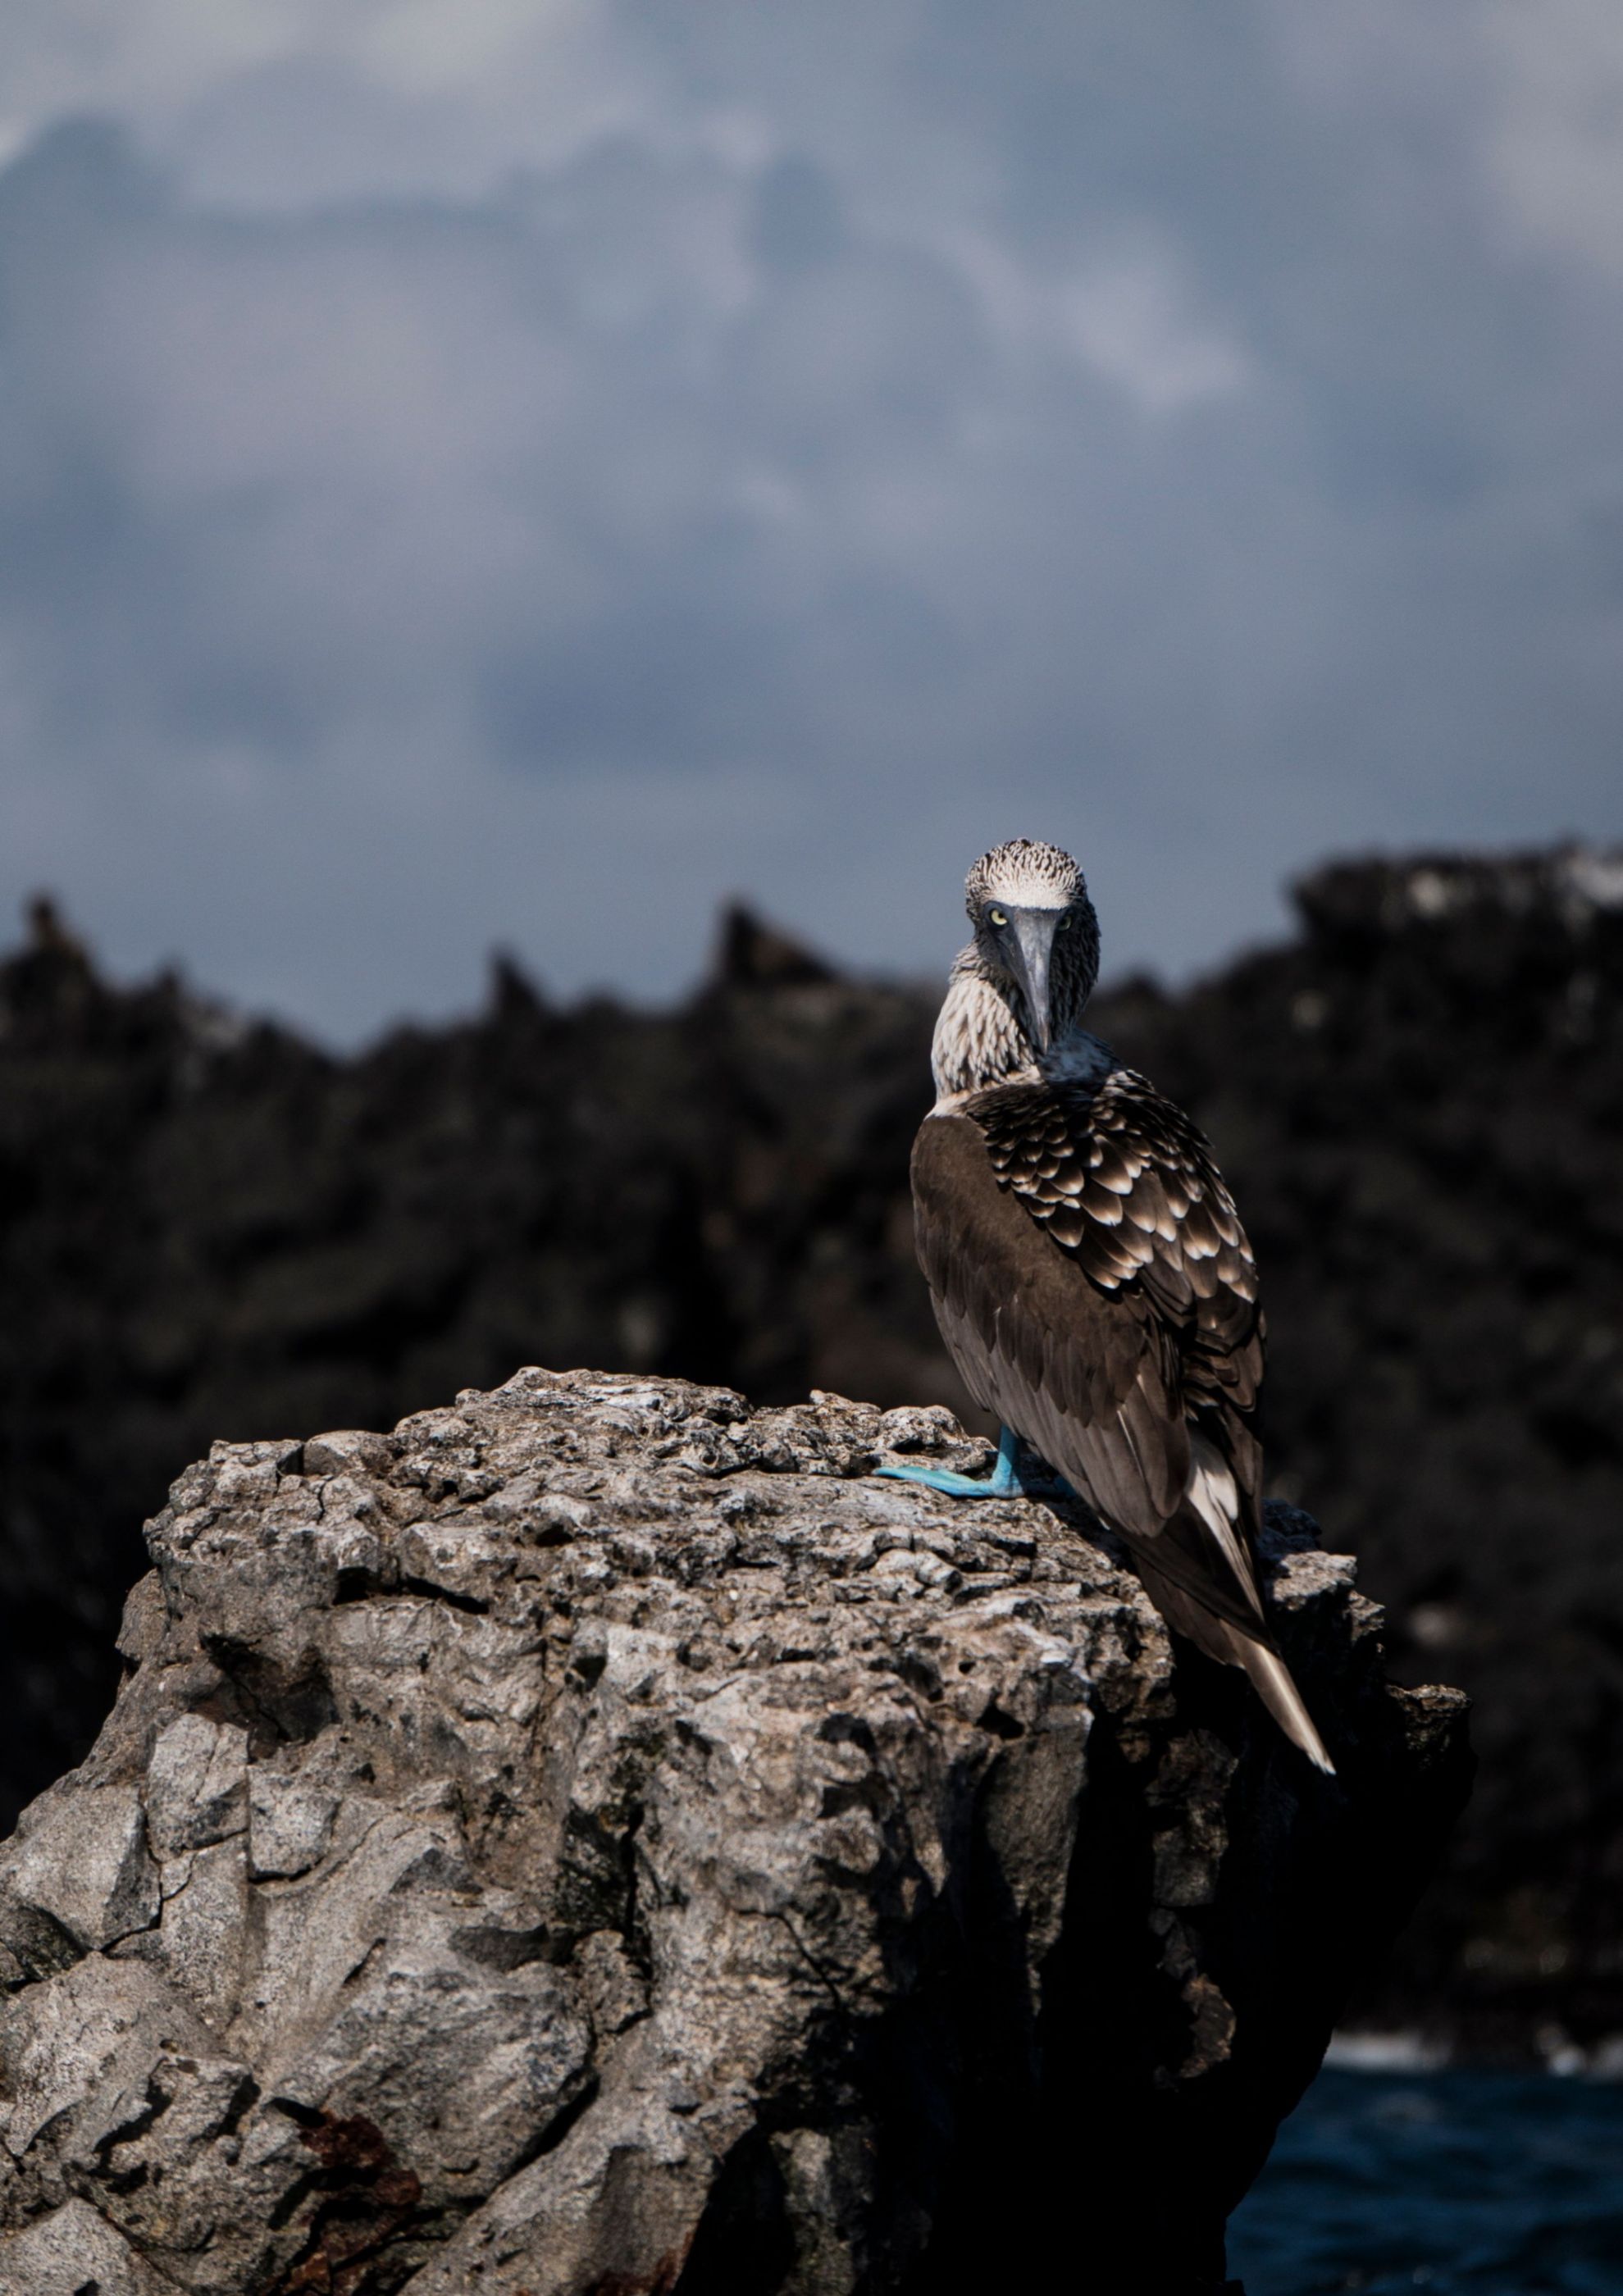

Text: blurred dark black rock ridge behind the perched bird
xmin=0 ymin=850 xmax=1623 ymax=2043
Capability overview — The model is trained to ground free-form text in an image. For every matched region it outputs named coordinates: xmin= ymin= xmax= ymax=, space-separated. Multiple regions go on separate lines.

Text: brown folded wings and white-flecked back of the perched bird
xmin=914 ymin=1070 xmax=1263 ymax=1633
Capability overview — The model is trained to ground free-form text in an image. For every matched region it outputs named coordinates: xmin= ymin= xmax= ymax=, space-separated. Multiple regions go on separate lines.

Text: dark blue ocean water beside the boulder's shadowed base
xmin=1229 ymin=2066 xmax=1623 ymax=2296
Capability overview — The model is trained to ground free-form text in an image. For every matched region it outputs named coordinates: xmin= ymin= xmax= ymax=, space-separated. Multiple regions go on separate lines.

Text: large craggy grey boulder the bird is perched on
xmin=0 ymin=1371 xmax=1469 ymax=2296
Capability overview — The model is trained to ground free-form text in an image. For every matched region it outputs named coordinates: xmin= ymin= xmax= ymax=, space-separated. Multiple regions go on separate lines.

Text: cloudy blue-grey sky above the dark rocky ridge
xmin=0 ymin=0 xmax=1623 ymax=1042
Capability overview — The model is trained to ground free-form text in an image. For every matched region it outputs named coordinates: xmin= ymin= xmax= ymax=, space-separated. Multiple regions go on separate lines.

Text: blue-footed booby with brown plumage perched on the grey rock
xmin=879 ymin=838 xmax=1334 ymax=1774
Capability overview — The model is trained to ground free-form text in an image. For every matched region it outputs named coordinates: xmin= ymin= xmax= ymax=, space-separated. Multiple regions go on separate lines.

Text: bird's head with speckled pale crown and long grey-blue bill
xmin=964 ymin=838 xmax=1100 ymax=1051
